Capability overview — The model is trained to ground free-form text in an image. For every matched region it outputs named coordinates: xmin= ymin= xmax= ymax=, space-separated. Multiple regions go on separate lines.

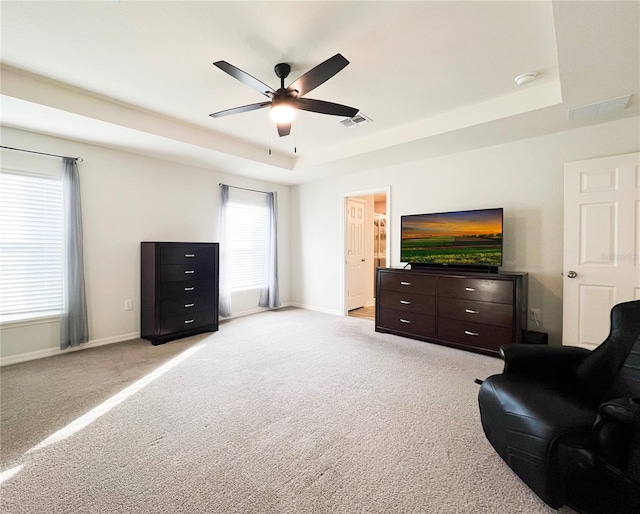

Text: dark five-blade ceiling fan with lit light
xmin=209 ymin=54 xmax=359 ymax=137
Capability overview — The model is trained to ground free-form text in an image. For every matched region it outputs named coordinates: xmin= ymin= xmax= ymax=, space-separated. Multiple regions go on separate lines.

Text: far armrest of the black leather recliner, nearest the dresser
xmin=500 ymin=344 xmax=591 ymax=378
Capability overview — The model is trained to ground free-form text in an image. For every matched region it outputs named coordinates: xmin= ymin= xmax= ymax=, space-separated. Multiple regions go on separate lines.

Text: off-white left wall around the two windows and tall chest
xmin=0 ymin=127 xmax=291 ymax=364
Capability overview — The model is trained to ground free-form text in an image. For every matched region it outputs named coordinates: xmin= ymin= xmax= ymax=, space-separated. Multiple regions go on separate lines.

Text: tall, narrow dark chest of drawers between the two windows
xmin=140 ymin=242 xmax=219 ymax=344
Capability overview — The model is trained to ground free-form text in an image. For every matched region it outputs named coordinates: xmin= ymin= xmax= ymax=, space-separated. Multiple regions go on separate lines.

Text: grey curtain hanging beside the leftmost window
xmin=60 ymin=157 xmax=89 ymax=350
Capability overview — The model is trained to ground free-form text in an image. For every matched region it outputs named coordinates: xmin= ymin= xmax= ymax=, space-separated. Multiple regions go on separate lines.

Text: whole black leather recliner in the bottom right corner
xmin=478 ymin=301 xmax=640 ymax=514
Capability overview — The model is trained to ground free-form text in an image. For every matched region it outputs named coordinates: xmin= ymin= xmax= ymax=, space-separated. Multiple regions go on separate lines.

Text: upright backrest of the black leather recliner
xmin=575 ymin=300 xmax=640 ymax=402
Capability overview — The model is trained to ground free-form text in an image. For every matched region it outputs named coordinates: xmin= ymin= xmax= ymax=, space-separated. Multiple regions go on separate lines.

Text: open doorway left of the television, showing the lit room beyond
xmin=343 ymin=187 xmax=389 ymax=319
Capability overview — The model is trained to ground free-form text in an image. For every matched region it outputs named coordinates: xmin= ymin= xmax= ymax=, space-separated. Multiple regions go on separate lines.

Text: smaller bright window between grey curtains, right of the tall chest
xmin=227 ymin=195 xmax=269 ymax=291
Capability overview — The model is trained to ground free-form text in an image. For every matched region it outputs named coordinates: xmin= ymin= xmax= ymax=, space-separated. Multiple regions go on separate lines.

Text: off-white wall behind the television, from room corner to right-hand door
xmin=291 ymin=117 xmax=640 ymax=344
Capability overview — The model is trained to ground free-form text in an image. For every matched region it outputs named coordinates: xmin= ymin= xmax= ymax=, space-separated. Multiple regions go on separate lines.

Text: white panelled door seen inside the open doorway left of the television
xmin=345 ymin=198 xmax=367 ymax=310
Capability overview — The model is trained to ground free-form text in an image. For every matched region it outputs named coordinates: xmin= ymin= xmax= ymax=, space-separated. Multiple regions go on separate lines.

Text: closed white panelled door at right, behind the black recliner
xmin=562 ymin=153 xmax=640 ymax=349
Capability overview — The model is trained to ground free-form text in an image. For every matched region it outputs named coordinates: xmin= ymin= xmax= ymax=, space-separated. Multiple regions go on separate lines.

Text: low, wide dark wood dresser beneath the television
xmin=376 ymin=268 xmax=527 ymax=355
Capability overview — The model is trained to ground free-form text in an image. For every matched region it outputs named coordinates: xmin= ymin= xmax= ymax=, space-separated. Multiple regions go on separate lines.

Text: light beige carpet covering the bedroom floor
xmin=0 ymin=309 xmax=570 ymax=514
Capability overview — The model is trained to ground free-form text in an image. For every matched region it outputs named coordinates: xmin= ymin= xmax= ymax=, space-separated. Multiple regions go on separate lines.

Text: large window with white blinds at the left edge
xmin=0 ymin=162 xmax=63 ymax=321
